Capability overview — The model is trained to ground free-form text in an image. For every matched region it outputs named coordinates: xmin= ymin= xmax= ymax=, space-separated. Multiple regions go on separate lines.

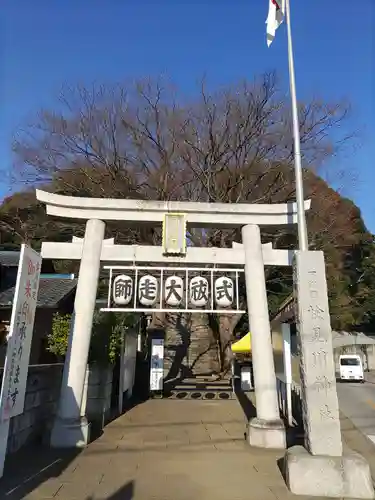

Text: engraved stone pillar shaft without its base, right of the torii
xmin=294 ymin=252 xmax=342 ymax=456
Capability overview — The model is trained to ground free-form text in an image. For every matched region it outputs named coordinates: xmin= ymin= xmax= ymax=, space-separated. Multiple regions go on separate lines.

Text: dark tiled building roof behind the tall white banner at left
xmin=0 ymin=278 xmax=77 ymax=309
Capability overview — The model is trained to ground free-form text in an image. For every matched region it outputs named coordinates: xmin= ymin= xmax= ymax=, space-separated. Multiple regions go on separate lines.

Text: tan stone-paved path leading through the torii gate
xmin=0 ymin=399 xmax=364 ymax=500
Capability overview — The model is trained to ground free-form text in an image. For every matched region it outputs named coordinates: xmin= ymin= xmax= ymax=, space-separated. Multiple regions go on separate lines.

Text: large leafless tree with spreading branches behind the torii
xmin=8 ymin=73 xmax=356 ymax=374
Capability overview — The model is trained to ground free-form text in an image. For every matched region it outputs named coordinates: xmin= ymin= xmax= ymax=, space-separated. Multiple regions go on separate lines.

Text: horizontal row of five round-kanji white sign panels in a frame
xmin=102 ymin=266 xmax=247 ymax=312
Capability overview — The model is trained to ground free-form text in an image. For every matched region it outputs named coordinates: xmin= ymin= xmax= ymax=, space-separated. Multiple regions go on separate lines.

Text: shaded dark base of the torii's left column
xmin=50 ymin=417 xmax=90 ymax=448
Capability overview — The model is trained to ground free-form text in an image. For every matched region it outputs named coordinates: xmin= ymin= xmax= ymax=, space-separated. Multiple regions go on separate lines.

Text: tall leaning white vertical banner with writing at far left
xmin=0 ymin=245 xmax=42 ymax=422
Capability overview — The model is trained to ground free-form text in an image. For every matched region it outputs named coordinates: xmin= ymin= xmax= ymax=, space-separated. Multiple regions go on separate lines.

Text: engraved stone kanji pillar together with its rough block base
xmin=284 ymin=251 xmax=374 ymax=498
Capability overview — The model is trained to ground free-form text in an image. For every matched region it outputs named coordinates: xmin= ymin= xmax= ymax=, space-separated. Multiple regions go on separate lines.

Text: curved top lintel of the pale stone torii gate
xmin=36 ymin=189 xmax=311 ymax=227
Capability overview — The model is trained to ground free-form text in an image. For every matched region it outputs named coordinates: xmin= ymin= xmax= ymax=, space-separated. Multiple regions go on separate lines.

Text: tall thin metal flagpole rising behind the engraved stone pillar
xmin=285 ymin=0 xmax=308 ymax=250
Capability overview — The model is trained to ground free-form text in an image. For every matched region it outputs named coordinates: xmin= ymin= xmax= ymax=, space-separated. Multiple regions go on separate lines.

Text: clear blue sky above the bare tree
xmin=0 ymin=0 xmax=375 ymax=233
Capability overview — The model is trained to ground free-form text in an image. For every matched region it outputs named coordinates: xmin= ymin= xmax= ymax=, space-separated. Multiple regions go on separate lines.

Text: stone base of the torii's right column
xmin=247 ymin=418 xmax=286 ymax=450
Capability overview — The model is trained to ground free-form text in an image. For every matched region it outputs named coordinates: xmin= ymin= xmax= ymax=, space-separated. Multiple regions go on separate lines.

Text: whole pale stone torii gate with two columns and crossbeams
xmin=36 ymin=190 xmax=310 ymax=448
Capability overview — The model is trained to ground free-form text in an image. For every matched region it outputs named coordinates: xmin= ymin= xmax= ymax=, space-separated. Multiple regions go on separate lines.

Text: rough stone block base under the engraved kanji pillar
xmin=284 ymin=446 xmax=374 ymax=499
